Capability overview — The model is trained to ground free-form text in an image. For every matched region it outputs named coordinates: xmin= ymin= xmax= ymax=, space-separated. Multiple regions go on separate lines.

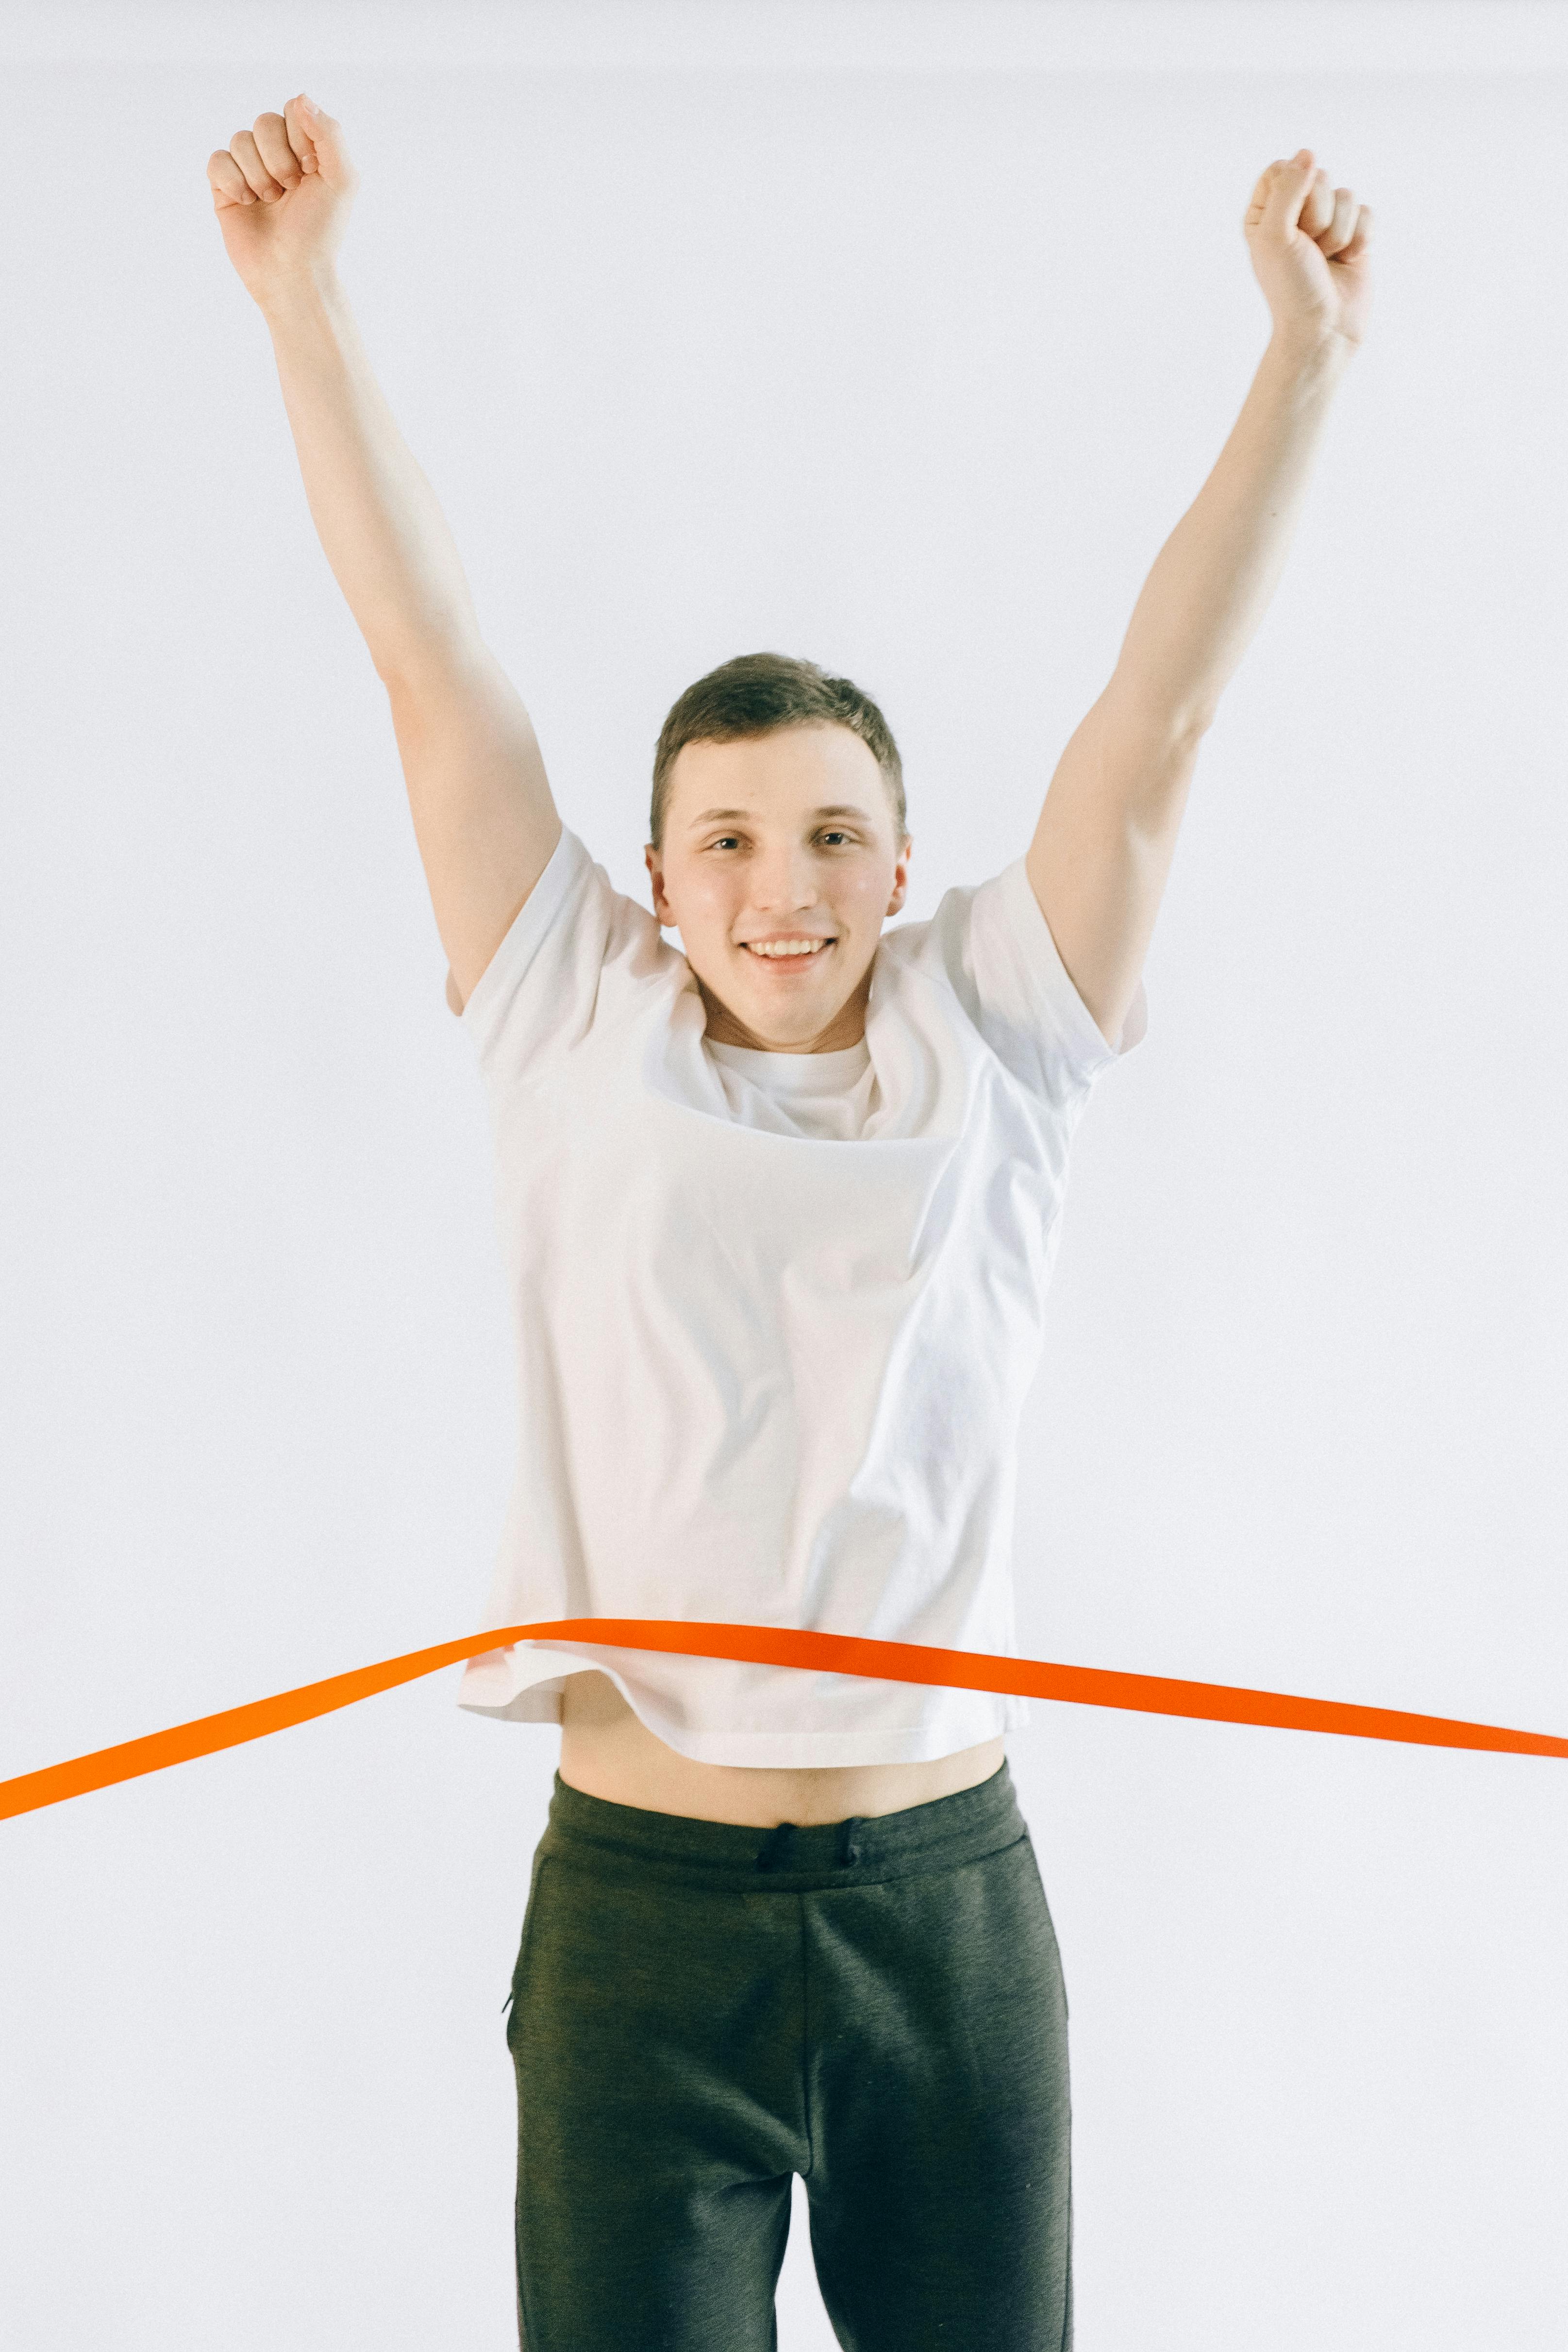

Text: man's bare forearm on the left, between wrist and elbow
xmin=263 ymin=273 xmax=480 ymax=682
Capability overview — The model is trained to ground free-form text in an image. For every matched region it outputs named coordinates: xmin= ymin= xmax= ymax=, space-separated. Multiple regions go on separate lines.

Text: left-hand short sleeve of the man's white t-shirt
xmin=461 ymin=826 xmax=670 ymax=1084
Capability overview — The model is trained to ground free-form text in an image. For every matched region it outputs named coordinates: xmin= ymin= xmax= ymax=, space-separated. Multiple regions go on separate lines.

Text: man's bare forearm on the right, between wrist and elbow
xmin=1107 ymin=336 xmax=1350 ymax=734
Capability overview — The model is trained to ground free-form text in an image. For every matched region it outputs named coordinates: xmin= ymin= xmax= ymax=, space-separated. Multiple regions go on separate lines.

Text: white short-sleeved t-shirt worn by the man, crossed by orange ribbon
xmin=447 ymin=830 xmax=1147 ymax=1768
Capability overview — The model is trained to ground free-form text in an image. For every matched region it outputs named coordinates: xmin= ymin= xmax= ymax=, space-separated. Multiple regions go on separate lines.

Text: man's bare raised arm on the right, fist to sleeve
xmin=1025 ymin=148 xmax=1370 ymax=1042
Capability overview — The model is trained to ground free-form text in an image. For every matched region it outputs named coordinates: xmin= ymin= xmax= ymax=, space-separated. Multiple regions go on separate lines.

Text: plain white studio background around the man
xmin=0 ymin=0 xmax=1568 ymax=2352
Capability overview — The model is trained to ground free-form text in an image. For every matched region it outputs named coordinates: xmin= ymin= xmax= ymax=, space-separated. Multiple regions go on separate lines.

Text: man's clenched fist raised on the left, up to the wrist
xmin=207 ymin=92 xmax=360 ymax=306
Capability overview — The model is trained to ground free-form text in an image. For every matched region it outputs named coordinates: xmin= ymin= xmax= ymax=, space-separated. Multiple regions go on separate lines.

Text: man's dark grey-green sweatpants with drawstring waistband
xmin=508 ymin=1764 xmax=1072 ymax=2352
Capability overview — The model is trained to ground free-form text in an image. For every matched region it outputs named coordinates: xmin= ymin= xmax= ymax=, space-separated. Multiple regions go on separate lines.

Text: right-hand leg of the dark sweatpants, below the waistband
xmin=806 ymin=1839 xmax=1072 ymax=2352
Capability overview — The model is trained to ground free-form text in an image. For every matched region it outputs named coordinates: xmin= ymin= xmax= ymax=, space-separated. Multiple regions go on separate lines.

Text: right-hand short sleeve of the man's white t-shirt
xmin=902 ymin=858 xmax=1150 ymax=1108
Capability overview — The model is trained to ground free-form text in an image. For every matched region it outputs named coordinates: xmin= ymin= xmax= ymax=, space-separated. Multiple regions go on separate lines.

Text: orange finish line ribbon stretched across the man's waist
xmin=0 ymin=1618 xmax=1568 ymax=1820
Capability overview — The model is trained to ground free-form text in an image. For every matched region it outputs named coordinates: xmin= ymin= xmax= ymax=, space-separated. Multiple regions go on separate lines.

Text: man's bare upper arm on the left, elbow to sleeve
xmin=388 ymin=642 xmax=562 ymax=1011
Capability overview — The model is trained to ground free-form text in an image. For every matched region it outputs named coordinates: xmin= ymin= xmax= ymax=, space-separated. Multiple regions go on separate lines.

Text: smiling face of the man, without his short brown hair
xmin=644 ymin=724 xmax=910 ymax=1054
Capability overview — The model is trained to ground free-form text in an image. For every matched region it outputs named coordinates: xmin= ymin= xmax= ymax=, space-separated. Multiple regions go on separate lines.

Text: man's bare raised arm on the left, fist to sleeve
xmin=207 ymin=97 xmax=562 ymax=1011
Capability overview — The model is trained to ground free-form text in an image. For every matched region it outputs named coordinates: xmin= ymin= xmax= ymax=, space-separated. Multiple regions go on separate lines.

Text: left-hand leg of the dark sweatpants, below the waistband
xmin=508 ymin=1853 xmax=804 ymax=2352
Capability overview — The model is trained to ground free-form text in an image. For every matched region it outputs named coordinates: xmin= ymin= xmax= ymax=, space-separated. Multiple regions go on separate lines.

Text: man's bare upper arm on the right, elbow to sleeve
xmin=1025 ymin=682 xmax=1201 ymax=1042
